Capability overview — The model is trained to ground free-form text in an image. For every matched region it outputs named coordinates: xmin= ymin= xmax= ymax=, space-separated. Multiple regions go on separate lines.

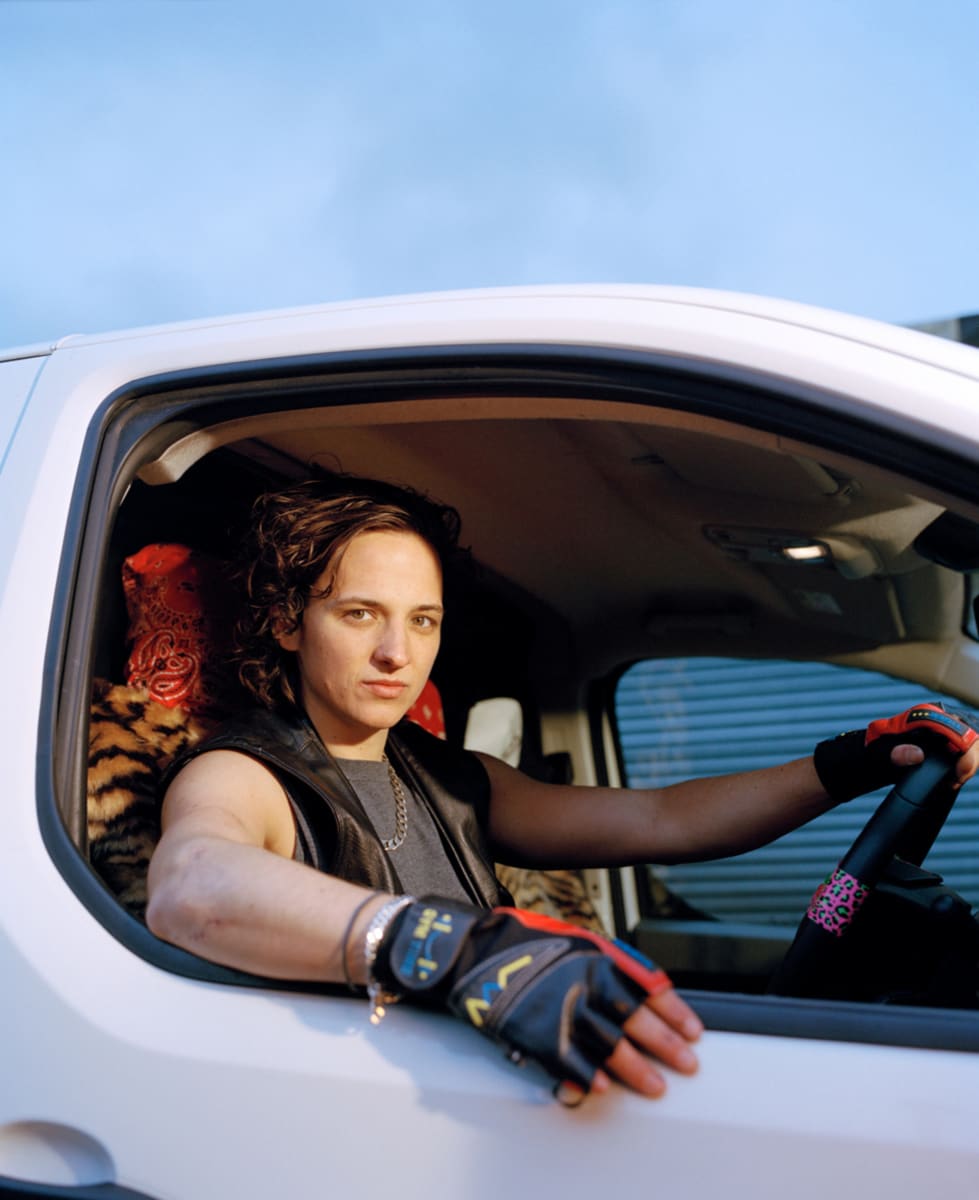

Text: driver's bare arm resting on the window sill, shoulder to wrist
xmin=146 ymin=750 xmax=389 ymax=983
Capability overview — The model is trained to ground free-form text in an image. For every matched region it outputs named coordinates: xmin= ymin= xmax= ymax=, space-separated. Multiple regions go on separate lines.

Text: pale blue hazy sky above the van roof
xmin=0 ymin=0 xmax=979 ymax=346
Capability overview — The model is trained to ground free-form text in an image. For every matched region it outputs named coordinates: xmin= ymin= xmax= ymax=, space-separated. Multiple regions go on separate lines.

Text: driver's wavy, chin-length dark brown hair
xmin=235 ymin=475 xmax=461 ymax=709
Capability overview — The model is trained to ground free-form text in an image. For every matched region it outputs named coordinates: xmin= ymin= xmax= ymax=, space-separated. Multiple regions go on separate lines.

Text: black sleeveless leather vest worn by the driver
xmin=176 ymin=709 xmax=511 ymax=907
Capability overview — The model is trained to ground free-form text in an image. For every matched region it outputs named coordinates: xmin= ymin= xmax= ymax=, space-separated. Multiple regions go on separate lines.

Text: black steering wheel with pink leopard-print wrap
xmin=768 ymin=750 xmax=955 ymax=996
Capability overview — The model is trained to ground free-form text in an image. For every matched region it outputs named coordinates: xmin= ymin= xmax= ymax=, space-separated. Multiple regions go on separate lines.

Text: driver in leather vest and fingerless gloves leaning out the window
xmin=146 ymin=476 xmax=979 ymax=1099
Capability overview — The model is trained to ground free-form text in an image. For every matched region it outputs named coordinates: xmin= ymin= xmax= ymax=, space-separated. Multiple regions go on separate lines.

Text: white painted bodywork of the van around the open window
xmin=0 ymin=288 xmax=979 ymax=1200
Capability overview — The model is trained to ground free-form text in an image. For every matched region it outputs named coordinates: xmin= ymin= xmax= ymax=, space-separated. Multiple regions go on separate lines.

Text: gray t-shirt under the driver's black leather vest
xmin=338 ymin=758 xmax=472 ymax=904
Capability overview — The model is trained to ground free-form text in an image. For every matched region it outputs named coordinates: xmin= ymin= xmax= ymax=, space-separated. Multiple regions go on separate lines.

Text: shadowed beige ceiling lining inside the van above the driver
xmin=113 ymin=406 xmax=971 ymax=686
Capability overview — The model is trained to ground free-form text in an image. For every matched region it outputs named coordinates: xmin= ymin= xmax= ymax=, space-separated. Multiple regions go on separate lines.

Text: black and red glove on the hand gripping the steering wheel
xmin=812 ymin=704 xmax=979 ymax=803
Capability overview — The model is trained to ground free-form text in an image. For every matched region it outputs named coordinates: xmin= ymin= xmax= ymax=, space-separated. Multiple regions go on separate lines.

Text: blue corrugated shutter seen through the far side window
xmin=615 ymin=659 xmax=979 ymax=925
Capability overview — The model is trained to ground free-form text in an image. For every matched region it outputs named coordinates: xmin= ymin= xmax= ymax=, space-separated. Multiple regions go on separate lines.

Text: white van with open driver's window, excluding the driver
xmin=0 ymin=287 xmax=979 ymax=1200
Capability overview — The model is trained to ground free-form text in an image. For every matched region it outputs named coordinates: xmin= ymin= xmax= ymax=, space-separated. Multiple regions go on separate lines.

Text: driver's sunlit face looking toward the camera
xmin=277 ymin=532 xmax=443 ymax=757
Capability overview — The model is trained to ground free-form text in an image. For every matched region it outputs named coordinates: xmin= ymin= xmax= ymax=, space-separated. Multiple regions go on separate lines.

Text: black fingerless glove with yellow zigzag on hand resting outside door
xmin=373 ymin=896 xmax=671 ymax=1091
